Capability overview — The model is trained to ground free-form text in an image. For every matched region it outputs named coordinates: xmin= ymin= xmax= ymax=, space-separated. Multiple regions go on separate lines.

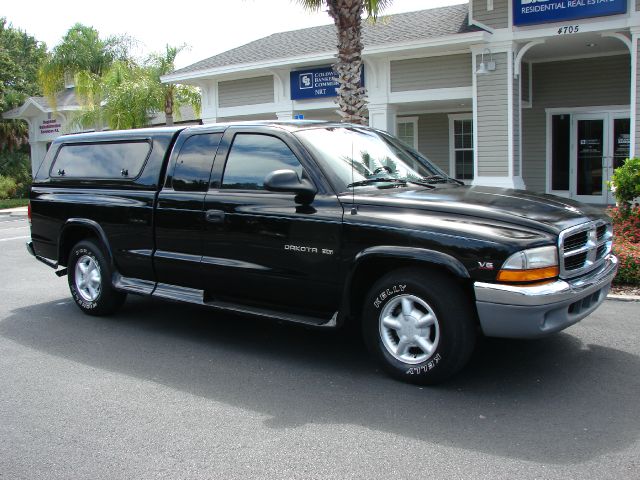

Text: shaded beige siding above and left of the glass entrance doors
xmin=522 ymin=55 xmax=637 ymax=191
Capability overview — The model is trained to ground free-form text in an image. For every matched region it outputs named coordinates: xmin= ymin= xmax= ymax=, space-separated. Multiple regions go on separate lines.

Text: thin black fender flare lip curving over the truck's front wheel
xmin=341 ymin=245 xmax=471 ymax=316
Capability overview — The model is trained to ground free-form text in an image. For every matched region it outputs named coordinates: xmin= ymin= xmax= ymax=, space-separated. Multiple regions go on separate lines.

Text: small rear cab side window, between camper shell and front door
xmin=171 ymin=133 xmax=222 ymax=192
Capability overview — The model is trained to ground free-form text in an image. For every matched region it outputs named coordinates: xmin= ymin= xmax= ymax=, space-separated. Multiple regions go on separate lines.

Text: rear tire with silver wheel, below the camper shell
xmin=68 ymin=240 xmax=127 ymax=315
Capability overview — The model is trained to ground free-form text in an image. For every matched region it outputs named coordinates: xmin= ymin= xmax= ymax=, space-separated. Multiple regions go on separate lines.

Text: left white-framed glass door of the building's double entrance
xmin=571 ymin=114 xmax=610 ymax=204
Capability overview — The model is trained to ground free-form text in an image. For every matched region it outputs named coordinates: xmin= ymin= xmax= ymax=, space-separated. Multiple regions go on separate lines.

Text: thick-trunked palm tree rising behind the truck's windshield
xmin=297 ymin=0 xmax=391 ymax=125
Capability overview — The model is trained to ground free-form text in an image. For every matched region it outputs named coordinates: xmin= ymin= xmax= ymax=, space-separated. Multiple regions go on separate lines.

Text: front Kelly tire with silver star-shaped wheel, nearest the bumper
xmin=362 ymin=268 xmax=476 ymax=385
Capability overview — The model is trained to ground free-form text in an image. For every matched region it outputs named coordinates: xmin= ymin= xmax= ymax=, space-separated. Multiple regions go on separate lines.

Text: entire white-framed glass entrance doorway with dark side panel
xmin=547 ymin=110 xmax=631 ymax=205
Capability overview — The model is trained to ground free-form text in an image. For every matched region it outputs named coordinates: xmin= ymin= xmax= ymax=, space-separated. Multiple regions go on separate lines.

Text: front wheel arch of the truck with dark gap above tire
xmin=340 ymin=246 xmax=472 ymax=322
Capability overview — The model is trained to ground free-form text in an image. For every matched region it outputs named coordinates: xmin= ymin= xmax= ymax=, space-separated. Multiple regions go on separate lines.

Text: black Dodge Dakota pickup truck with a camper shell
xmin=27 ymin=121 xmax=617 ymax=383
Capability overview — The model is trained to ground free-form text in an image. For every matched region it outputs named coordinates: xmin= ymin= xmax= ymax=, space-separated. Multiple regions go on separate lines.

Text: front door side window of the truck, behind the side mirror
xmin=222 ymin=133 xmax=303 ymax=190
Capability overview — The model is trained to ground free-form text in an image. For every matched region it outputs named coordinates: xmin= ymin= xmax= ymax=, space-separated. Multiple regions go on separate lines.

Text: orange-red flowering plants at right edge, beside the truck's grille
xmin=608 ymin=208 xmax=640 ymax=285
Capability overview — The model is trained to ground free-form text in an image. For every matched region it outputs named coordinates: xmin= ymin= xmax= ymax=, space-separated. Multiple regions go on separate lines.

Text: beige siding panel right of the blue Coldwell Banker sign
xmin=391 ymin=54 xmax=472 ymax=92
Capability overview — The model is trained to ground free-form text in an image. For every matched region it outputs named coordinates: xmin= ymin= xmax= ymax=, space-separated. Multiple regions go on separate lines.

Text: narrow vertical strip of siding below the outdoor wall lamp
xmin=476 ymin=53 xmax=509 ymax=177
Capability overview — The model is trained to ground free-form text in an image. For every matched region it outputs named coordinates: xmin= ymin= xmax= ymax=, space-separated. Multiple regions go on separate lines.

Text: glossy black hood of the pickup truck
xmin=341 ymin=184 xmax=607 ymax=234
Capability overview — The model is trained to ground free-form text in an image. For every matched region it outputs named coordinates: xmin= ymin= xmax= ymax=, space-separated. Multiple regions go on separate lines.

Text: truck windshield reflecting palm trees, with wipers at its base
xmin=295 ymin=125 xmax=452 ymax=191
